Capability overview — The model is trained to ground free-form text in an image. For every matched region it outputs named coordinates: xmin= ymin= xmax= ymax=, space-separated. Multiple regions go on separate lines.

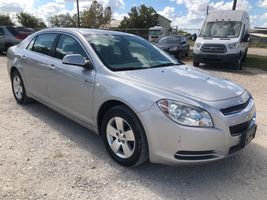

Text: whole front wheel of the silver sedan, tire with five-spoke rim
xmin=101 ymin=106 xmax=148 ymax=167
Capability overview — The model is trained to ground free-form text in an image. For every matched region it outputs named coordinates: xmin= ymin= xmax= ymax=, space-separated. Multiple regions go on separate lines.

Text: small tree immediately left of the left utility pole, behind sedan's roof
xmin=48 ymin=13 xmax=77 ymax=27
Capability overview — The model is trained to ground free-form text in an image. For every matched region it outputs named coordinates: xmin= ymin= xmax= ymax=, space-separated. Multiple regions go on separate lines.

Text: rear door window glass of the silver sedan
xmin=32 ymin=33 xmax=57 ymax=55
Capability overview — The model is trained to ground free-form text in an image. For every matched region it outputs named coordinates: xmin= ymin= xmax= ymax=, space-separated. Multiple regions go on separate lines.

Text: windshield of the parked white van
xmin=200 ymin=21 xmax=241 ymax=38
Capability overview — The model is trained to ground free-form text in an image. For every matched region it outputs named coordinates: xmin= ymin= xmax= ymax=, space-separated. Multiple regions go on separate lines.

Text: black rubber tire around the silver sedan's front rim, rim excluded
xmin=101 ymin=106 xmax=143 ymax=166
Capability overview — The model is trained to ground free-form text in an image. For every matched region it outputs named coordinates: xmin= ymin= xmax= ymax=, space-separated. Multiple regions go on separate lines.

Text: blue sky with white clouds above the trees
xmin=0 ymin=0 xmax=267 ymax=29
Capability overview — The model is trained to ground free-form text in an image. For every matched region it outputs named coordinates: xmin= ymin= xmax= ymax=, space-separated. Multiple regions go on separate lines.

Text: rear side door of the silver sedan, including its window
xmin=21 ymin=33 xmax=57 ymax=101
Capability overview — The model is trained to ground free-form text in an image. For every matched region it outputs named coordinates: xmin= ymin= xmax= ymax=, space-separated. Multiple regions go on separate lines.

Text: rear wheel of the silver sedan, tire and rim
xmin=11 ymin=70 xmax=30 ymax=104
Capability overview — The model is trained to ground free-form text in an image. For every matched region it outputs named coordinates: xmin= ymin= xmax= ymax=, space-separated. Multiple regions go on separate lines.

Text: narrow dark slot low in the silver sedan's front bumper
xmin=174 ymin=150 xmax=218 ymax=160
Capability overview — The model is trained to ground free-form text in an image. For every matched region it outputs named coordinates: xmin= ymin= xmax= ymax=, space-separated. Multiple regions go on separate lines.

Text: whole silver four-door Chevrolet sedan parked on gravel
xmin=7 ymin=28 xmax=257 ymax=166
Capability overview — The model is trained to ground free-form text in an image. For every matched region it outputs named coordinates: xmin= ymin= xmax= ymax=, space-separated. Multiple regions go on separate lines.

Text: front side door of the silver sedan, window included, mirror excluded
xmin=47 ymin=34 xmax=95 ymax=124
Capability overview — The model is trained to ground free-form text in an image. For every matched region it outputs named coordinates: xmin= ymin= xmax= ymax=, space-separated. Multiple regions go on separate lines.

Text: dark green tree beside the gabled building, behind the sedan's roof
xmin=120 ymin=4 xmax=158 ymax=28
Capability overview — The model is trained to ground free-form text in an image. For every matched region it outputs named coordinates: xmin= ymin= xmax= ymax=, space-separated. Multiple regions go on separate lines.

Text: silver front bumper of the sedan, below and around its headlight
xmin=139 ymin=99 xmax=256 ymax=165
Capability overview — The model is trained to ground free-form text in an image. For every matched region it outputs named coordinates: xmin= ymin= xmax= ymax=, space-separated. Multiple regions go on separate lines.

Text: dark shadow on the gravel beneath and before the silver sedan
xmin=20 ymin=102 xmax=267 ymax=199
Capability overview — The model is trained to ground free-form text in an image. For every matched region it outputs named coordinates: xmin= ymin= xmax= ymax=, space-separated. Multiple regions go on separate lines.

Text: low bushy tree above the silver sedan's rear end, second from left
xmin=16 ymin=12 xmax=46 ymax=28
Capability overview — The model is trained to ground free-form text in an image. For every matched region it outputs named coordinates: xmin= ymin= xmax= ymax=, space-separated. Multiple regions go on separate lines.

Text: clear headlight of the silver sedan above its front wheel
xmin=157 ymin=99 xmax=213 ymax=127
